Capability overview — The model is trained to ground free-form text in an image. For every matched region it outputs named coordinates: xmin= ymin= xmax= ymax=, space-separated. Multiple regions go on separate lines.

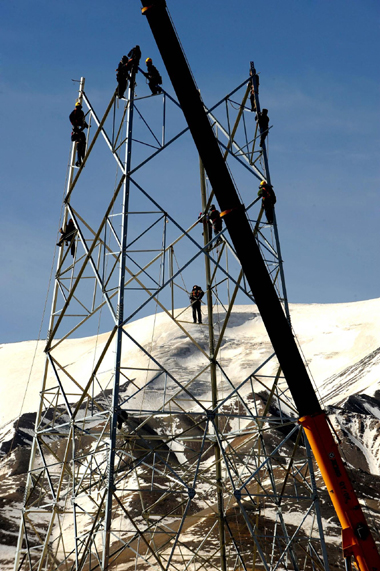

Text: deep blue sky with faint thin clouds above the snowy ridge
xmin=0 ymin=0 xmax=380 ymax=342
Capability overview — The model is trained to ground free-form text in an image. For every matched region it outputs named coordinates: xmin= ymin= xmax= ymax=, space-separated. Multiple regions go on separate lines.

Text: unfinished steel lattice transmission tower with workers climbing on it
xmin=14 ymin=59 xmax=328 ymax=571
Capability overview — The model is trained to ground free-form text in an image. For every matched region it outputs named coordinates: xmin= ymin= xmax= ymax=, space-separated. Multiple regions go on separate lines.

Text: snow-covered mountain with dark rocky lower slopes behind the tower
xmin=0 ymin=299 xmax=380 ymax=570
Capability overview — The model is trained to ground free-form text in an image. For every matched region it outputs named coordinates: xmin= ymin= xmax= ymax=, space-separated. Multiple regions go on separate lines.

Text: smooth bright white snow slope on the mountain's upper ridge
xmin=0 ymin=299 xmax=380 ymax=427
